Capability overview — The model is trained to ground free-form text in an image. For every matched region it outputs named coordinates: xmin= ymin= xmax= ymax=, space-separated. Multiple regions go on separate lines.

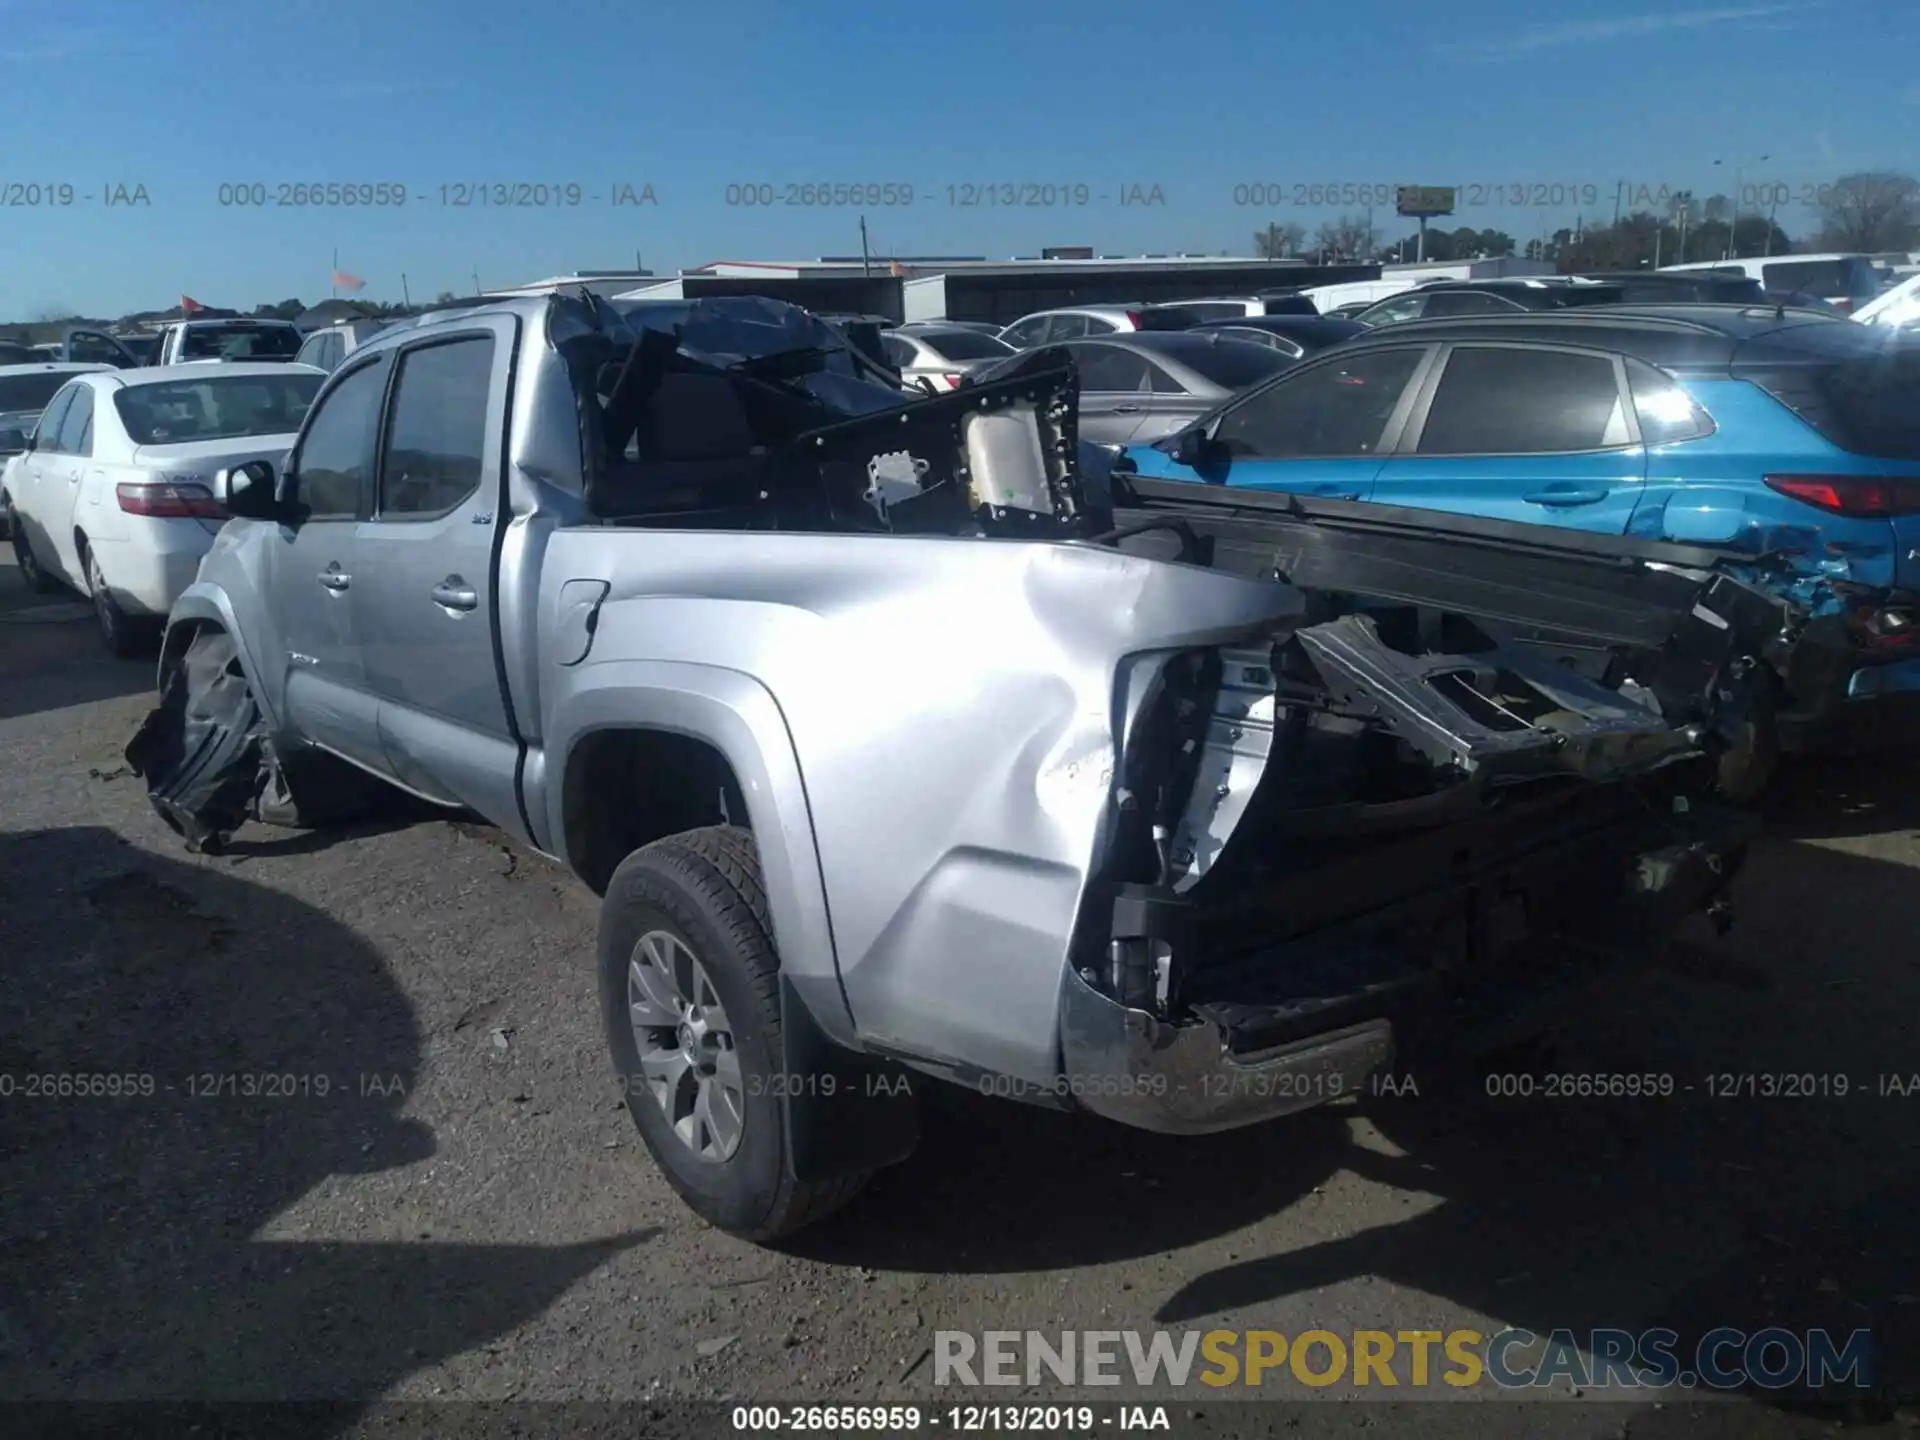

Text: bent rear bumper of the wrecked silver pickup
xmin=1060 ymin=794 xmax=1755 ymax=1135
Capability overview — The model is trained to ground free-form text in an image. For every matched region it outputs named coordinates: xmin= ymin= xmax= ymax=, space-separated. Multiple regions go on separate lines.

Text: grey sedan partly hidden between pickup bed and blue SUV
xmin=1058 ymin=330 xmax=1292 ymax=445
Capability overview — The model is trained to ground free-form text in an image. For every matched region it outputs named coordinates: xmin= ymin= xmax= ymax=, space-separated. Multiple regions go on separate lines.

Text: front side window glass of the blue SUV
xmin=1213 ymin=348 xmax=1427 ymax=459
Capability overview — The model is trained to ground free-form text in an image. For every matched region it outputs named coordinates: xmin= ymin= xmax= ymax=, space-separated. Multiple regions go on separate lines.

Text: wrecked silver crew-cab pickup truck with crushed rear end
xmin=129 ymin=296 xmax=1764 ymax=1240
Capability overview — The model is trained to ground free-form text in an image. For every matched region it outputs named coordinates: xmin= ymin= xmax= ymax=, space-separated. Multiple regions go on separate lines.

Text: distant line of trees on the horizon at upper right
xmin=1254 ymin=171 xmax=1920 ymax=275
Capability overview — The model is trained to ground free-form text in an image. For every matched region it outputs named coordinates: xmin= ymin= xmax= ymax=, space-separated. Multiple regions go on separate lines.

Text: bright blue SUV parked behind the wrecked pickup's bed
xmin=1116 ymin=305 xmax=1920 ymax=747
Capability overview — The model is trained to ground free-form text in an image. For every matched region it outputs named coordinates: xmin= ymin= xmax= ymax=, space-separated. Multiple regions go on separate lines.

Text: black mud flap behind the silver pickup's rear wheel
xmin=780 ymin=975 xmax=927 ymax=1181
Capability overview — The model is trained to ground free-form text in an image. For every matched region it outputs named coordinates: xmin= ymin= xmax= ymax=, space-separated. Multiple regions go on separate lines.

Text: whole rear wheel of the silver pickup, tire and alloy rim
xmin=599 ymin=826 xmax=868 ymax=1240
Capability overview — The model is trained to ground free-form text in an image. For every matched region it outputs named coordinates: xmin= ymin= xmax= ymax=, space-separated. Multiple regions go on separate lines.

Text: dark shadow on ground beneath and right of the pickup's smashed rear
xmin=791 ymin=766 xmax=1920 ymax=1413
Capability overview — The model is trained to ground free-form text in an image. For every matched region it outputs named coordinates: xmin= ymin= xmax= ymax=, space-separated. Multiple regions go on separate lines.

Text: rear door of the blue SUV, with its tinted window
xmin=1373 ymin=344 xmax=1647 ymax=534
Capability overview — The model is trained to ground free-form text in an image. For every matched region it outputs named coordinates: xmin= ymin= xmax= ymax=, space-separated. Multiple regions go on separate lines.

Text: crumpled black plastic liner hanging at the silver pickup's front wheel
xmin=127 ymin=630 xmax=267 ymax=854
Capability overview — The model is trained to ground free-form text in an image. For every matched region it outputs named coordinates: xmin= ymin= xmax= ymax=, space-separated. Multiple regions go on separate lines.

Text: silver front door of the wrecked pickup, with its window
xmin=269 ymin=355 xmax=392 ymax=774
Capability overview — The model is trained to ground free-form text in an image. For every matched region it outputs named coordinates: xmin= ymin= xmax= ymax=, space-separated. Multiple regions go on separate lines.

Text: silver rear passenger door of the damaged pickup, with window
xmin=353 ymin=317 xmax=518 ymax=818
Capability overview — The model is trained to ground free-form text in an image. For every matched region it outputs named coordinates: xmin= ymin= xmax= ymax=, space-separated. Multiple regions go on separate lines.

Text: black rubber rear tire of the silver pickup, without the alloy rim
xmin=599 ymin=826 xmax=868 ymax=1240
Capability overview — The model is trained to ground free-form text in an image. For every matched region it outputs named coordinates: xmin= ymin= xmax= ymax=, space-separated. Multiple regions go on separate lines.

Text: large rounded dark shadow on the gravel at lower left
xmin=0 ymin=828 xmax=649 ymax=1434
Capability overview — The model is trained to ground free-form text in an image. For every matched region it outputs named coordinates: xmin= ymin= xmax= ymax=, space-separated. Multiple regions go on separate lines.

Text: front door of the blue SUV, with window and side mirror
xmin=1129 ymin=346 xmax=1438 ymax=499
